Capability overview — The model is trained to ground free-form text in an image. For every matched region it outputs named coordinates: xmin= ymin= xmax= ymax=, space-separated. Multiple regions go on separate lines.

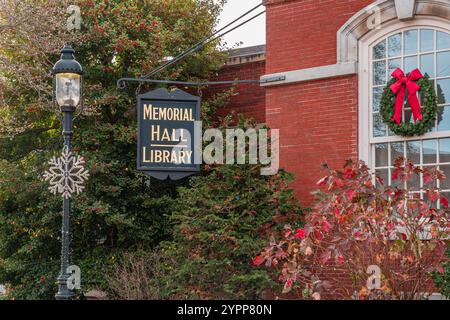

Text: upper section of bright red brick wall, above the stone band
xmin=266 ymin=0 xmax=374 ymax=73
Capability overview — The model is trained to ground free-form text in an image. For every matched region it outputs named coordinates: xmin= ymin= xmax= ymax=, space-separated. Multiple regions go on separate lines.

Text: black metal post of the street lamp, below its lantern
xmin=55 ymin=106 xmax=75 ymax=300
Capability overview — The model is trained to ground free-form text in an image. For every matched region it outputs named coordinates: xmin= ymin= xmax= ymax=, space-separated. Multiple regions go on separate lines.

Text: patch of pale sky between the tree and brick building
xmin=217 ymin=0 xmax=266 ymax=48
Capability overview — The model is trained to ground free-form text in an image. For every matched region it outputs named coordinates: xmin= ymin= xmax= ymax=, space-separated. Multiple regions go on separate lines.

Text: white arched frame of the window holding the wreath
xmin=358 ymin=17 xmax=450 ymax=167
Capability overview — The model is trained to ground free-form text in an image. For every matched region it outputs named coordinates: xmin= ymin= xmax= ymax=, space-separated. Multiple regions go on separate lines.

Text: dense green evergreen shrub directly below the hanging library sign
xmin=161 ymin=165 xmax=301 ymax=299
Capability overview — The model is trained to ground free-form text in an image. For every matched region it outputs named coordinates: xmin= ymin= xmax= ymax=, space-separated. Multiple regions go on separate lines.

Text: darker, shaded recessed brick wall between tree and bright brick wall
xmin=209 ymin=61 xmax=266 ymax=123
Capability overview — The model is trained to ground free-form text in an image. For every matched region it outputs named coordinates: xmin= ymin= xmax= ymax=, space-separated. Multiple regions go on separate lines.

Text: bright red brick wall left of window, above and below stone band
xmin=266 ymin=0 xmax=373 ymax=205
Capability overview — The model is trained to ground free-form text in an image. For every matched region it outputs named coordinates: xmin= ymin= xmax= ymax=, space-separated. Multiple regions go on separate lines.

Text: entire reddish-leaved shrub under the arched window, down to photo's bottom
xmin=256 ymin=158 xmax=449 ymax=299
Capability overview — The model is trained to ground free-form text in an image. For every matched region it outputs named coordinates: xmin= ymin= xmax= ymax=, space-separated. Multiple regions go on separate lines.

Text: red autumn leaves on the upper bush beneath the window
xmin=253 ymin=158 xmax=449 ymax=294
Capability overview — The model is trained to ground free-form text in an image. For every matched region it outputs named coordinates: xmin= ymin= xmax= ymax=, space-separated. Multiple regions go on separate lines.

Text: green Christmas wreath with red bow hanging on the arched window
xmin=380 ymin=69 xmax=438 ymax=137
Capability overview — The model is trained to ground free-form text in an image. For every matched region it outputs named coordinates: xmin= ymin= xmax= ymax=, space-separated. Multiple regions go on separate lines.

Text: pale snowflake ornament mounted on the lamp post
xmin=44 ymin=148 xmax=89 ymax=199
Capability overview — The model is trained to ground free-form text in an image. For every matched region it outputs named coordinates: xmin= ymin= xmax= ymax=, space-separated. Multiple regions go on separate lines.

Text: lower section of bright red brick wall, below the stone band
xmin=266 ymin=76 xmax=358 ymax=205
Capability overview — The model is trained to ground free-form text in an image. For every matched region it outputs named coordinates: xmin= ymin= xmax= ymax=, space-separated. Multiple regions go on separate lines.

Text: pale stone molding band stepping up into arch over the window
xmin=261 ymin=0 xmax=450 ymax=86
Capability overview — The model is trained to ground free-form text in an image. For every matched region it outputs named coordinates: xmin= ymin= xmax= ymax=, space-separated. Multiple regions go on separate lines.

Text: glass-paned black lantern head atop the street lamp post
xmin=52 ymin=45 xmax=83 ymax=108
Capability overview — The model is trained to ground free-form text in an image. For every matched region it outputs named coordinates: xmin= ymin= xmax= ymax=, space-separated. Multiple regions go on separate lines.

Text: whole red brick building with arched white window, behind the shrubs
xmin=219 ymin=0 xmax=450 ymax=204
